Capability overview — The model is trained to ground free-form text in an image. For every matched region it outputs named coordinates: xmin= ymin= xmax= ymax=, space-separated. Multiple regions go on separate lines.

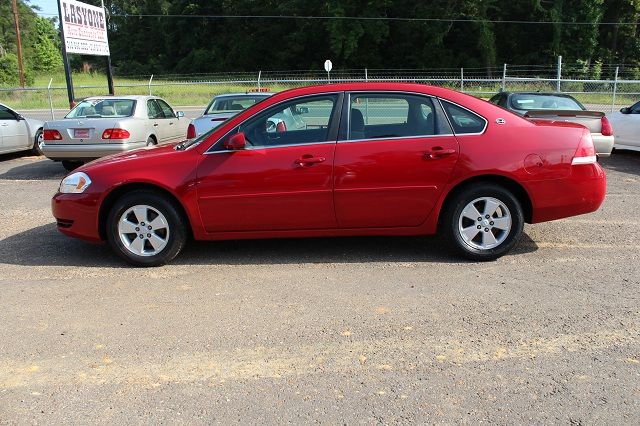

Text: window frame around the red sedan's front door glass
xmin=203 ymin=91 xmax=344 ymax=155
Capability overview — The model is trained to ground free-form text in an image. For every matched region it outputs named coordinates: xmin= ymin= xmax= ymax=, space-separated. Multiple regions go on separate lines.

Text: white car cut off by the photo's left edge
xmin=0 ymin=104 xmax=44 ymax=155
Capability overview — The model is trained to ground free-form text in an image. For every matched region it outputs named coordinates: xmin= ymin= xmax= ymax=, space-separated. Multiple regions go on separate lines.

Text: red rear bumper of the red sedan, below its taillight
xmin=527 ymin=163 xmax=607 ymax=223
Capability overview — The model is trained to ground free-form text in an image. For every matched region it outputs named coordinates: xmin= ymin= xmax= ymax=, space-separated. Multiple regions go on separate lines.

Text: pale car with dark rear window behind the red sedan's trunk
xmin=489 ymin=92 xmax=614 ymax=157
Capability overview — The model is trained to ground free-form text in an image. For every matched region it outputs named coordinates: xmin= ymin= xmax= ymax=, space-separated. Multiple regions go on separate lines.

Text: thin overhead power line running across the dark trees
xmin=41 ymin=13 xmax=638 ymax=25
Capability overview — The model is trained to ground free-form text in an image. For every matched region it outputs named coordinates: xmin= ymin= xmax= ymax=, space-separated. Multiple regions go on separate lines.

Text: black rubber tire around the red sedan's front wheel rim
xmin=106 ymin=190 xmax=187 ymax=266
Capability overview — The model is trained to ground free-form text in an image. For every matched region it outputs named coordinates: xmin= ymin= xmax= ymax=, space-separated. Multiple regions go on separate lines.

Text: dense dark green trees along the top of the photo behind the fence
xmin=0 ymin=0 xmax=640 ymax=85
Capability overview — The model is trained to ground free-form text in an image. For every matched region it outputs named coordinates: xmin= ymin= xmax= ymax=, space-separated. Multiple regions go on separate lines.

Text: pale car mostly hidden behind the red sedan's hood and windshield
xmin=187 ymin=92 xmax=273 ymax=139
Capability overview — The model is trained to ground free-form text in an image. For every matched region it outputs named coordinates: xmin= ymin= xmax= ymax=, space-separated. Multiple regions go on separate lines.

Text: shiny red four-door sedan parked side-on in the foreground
xmin=52 ymin=83 xmax=606 ymax=266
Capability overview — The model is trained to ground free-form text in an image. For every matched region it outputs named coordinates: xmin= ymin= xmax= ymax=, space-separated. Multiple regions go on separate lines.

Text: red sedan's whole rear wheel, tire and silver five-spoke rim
xmin=442 ymin=183 xmax=524 ymax=261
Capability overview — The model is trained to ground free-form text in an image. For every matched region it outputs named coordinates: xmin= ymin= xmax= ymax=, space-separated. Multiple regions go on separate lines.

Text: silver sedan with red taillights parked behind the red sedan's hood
xmin=42 ymin=96 xmax=187 ymax=170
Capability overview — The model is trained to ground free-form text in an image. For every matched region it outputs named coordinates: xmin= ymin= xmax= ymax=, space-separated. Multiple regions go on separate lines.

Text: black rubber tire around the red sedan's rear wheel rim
xmin=440 ymin=183 xmax=524 ymax=261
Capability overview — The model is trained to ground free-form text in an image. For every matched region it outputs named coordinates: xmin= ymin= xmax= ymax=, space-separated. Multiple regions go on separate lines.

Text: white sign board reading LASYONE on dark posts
xmin=59 ymin=0 xmax=109 ymax=56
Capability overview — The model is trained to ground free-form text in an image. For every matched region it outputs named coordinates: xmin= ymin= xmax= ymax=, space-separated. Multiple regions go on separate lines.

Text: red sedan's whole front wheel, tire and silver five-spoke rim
xmin=107 ymin=191 xmax=187 ymax=266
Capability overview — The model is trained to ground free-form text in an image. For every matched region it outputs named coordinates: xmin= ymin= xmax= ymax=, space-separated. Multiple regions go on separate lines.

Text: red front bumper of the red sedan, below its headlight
xmin=51 ymin=193 xmax=102 ymax=242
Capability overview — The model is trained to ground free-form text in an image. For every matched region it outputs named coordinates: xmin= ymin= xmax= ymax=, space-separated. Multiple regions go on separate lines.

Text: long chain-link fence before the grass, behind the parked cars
xmin=0 ymin=62 xmax=640 ymax=120
